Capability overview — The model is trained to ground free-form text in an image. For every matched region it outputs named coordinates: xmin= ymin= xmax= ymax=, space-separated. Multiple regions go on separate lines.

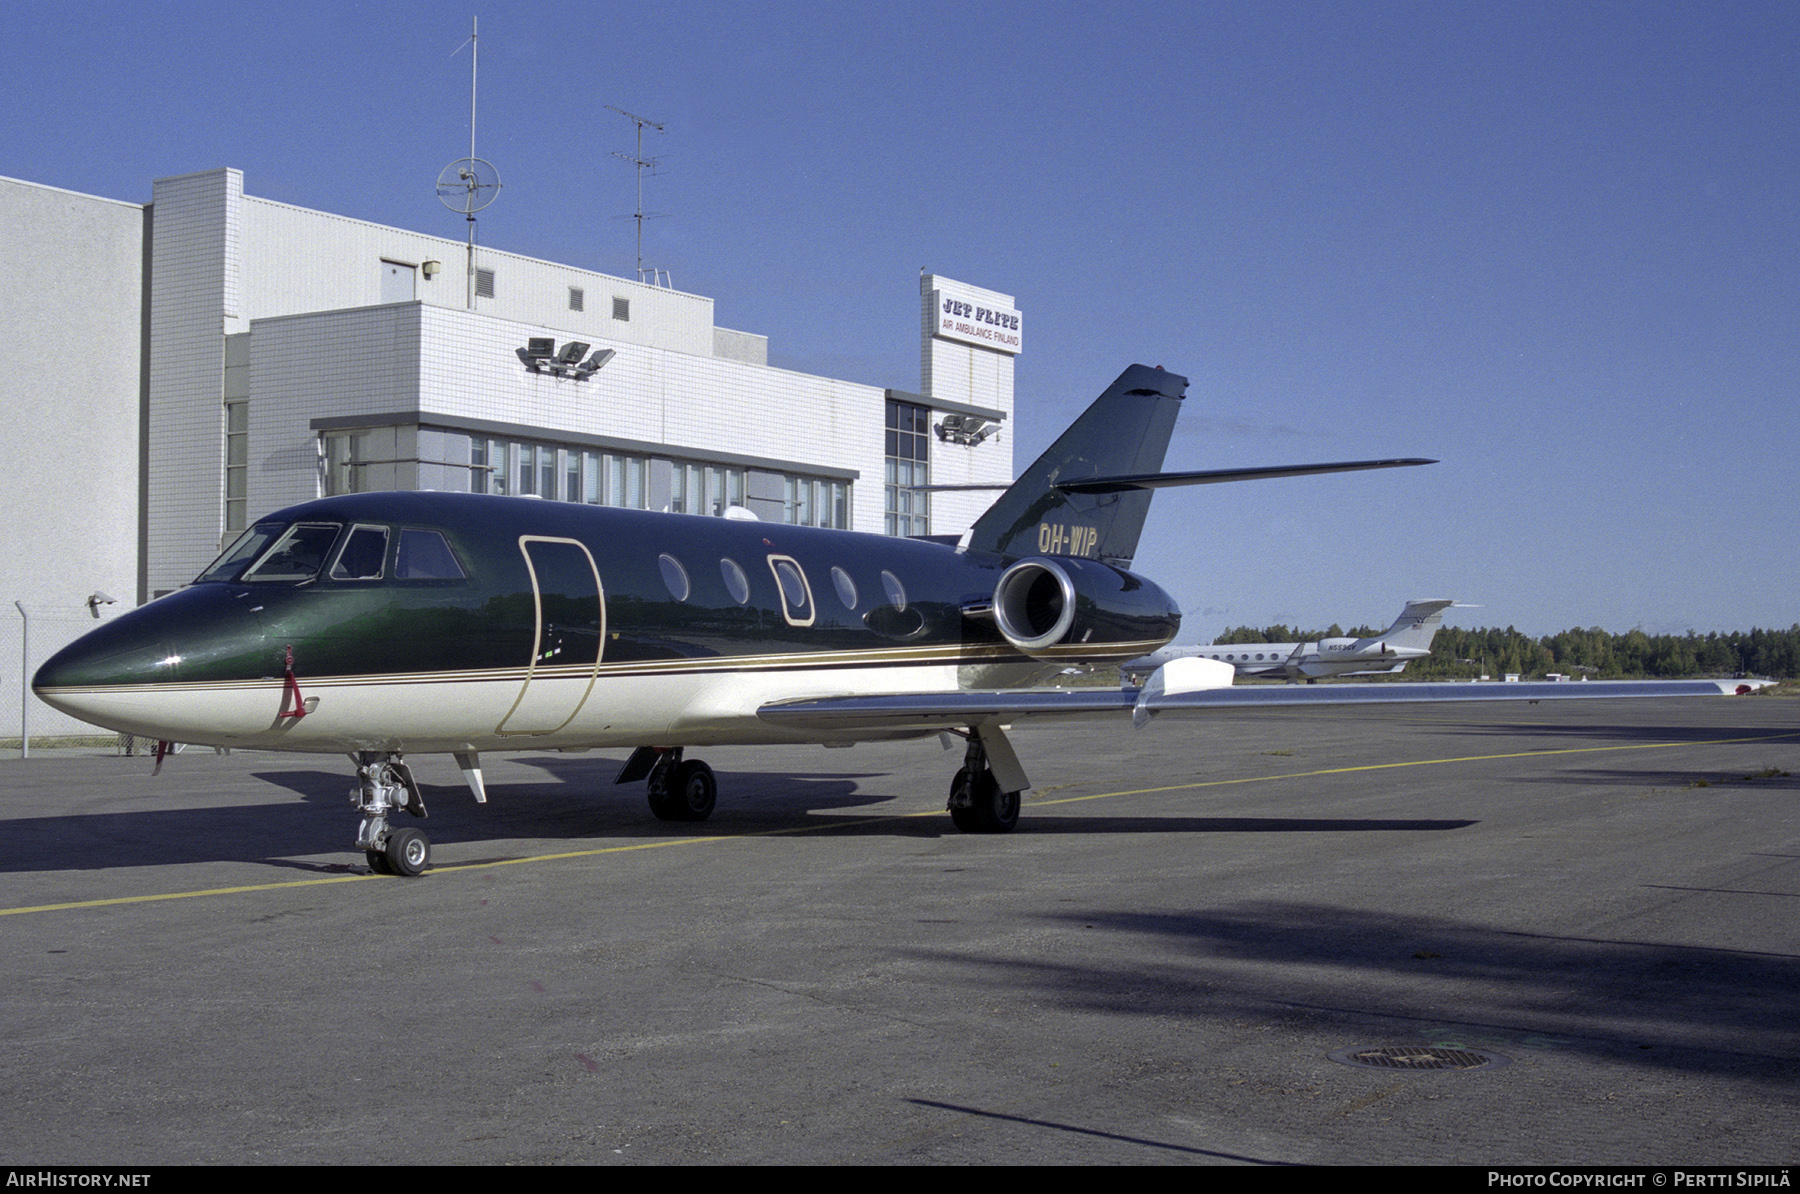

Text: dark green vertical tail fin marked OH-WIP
xmin=968 ymin=366 xmax=1188 ymax=567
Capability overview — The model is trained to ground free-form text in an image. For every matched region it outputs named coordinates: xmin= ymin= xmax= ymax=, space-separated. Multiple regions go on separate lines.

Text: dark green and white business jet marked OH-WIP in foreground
xmin=32 ymin=366 xmax=1764 ymax=875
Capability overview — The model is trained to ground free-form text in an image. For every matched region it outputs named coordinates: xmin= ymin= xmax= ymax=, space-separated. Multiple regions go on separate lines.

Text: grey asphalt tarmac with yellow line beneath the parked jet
xmin=0 ymin=697 xmax=1800 ymax=1165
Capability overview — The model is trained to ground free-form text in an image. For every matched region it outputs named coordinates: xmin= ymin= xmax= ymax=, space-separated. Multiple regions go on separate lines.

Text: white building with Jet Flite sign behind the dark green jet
xmin=0 ymin=169 xmax=1022 ymax=738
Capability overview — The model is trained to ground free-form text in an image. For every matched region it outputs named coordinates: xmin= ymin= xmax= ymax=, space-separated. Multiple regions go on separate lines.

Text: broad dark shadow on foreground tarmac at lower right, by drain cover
xmin=913 ymin=900 xmax=1800 ymax=1099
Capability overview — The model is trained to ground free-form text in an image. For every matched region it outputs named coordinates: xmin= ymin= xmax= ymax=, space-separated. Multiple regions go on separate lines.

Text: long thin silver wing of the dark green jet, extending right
xmin=756 ymin=679 xmax=1762 ymax=733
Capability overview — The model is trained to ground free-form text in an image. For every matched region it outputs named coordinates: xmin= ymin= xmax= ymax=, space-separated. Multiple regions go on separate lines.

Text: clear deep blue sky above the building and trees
xmin=0 ymin=0 xmax=1800 ymax=641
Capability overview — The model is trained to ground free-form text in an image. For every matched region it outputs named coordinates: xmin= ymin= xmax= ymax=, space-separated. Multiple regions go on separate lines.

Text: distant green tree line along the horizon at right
xmin=1215 ymin=625 xmax=1800 ymax=679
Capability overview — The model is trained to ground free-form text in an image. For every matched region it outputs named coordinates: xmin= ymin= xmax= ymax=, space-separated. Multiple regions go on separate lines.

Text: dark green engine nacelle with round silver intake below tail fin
xmin=994 ymin=556 xmax=1181 ymax=657
